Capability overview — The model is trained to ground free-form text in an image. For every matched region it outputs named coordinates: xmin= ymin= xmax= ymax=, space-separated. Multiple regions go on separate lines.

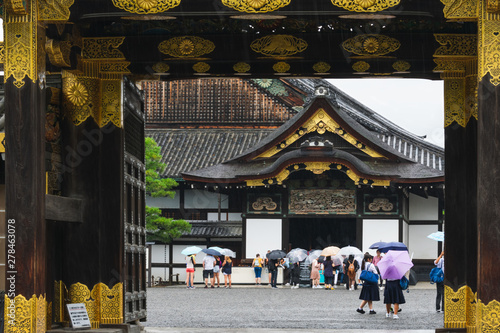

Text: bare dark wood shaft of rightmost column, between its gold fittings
xmin=476 ymin=75 xmax=500 ymax=304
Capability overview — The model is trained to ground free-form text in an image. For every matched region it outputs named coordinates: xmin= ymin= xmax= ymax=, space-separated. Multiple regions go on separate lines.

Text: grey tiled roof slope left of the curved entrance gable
xmin=146 ymin=128 xmax=274 ymax=178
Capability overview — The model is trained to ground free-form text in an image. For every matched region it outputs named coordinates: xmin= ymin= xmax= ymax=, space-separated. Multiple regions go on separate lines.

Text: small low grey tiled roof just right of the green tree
xmin=182 ymin=221 xmax=243 ymax=238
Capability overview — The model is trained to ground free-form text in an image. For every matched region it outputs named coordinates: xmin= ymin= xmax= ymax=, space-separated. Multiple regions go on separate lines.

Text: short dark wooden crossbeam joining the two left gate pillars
xmin=45 ymin=194 xmax=83 ymax=222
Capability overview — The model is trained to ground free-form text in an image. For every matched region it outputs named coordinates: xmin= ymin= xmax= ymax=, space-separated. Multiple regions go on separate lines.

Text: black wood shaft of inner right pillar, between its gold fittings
xmin=444 ymin=118 xmax=477 ymax=290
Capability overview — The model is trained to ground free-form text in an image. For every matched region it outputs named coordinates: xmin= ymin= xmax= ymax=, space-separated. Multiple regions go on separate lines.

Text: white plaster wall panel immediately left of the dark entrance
xmin=246 ymin=219 xmax=282 ymax=258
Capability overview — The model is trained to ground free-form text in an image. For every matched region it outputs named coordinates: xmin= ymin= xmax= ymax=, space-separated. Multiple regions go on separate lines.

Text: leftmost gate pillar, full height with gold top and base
xmin=4 ymin=1 xmax=47 ymax=333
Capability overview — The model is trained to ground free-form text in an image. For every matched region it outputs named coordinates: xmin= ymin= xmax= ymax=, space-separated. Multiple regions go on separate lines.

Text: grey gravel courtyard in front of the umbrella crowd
xmin=143 ymin=283 xmax=443 ymax=330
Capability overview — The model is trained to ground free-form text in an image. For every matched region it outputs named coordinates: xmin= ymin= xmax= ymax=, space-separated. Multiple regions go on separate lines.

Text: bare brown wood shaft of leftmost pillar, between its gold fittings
xmin=5 ymin=77 xmax=46 ymax=298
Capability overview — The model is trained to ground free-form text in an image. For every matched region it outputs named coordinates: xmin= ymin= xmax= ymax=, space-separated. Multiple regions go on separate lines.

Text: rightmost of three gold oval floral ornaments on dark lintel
xmin=342 ymin=34 xmax=401 ymax=56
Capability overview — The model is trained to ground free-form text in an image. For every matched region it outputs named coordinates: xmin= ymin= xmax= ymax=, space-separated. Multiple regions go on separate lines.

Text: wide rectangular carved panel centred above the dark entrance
xmin=288 ymin=189 xmax=356 ymax=214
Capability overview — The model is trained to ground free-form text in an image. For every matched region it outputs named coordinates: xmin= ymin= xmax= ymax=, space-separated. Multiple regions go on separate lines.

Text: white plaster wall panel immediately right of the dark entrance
xmin=360 ymin=219 xmax=399 ymax=255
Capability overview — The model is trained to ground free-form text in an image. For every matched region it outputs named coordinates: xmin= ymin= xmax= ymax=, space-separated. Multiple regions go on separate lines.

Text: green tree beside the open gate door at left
xmin=145 ymin=138 xmax=191 ymax=243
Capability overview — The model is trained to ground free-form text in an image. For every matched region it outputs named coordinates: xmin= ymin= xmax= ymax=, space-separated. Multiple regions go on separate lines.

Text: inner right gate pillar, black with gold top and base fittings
xmin=434 ymin=34 xmax=477 ymax=332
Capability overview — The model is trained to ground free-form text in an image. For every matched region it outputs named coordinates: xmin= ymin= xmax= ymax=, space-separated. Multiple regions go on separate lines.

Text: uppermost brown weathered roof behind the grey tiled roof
xmin=142 ymin=78 xmax=305 ymax=127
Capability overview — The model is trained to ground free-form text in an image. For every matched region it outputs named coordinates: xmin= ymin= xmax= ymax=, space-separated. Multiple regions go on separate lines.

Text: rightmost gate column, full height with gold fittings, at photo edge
xmin=476 ymin=0 xmax=500 ymax=332
